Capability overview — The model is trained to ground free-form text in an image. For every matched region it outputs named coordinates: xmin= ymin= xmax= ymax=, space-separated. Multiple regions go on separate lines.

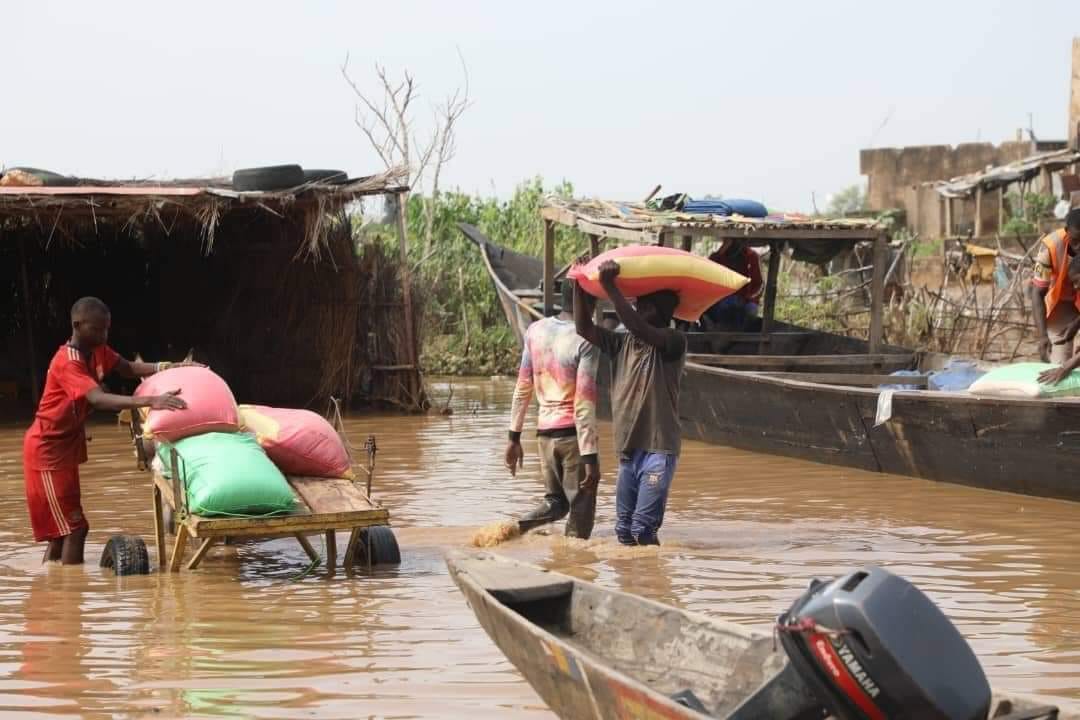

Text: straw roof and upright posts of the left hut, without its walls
xmin=0 ymin=167 xmax=423 ymax=409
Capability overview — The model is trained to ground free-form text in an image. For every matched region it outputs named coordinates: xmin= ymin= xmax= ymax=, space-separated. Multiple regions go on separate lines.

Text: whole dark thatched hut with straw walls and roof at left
xmin=0 ymin=169 xmax=424 ymax=416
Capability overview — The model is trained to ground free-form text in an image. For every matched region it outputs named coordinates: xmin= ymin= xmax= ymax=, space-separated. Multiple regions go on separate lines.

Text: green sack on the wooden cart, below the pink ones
xmin=158 ymin=433 xmax=296 ymax=517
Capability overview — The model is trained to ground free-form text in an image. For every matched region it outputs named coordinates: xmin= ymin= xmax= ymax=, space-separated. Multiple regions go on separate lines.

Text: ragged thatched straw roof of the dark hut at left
xmin=0 ymin=167 xmax=408 ymax=253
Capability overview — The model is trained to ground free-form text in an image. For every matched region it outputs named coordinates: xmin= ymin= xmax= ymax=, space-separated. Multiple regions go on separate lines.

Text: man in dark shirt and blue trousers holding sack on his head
xmin=573 ymin=260 xmax=686 ymax=545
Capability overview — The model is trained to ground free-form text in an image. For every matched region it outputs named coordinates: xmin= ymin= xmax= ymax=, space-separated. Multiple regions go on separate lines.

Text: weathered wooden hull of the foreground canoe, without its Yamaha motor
xmin=446 ymin=553 xmax=1080 ymax=720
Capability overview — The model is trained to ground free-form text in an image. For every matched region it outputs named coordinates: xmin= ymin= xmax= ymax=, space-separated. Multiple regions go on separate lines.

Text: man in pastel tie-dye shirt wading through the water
xmin=505 ymin=280 xmax=600 ymax=539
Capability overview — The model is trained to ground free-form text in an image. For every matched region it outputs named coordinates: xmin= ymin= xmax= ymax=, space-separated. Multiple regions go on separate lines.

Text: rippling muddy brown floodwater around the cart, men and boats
xmin=0 ymin=380 xmax=1080 ymax=720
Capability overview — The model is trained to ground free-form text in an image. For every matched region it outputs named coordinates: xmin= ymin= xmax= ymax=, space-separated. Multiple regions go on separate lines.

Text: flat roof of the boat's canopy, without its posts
xmin=541 ymin=196 xmax=885 ymax=242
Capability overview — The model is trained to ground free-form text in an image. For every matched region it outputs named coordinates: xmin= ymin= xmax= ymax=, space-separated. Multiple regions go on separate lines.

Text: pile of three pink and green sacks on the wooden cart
xmin=135 ymin=367 xmax=352 ymax=517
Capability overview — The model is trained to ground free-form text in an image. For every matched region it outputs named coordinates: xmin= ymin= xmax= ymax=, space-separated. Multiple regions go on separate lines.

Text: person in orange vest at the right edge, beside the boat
xmin=1029 ymin=207 xmax=1080 ymax=365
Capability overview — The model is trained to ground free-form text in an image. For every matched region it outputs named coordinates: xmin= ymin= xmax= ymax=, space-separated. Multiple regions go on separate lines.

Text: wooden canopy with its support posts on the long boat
xmin=540 ymin=198 xmax=889 ymax=356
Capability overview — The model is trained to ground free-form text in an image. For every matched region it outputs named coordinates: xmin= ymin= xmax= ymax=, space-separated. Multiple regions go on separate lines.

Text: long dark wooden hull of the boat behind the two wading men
xmin=467 ymin=228 xmax=1080 ymax=501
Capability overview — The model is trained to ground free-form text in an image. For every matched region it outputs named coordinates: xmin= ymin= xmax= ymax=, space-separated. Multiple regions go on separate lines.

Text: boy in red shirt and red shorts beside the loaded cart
xmin=23 ymin=298 xmax=187 ymax=565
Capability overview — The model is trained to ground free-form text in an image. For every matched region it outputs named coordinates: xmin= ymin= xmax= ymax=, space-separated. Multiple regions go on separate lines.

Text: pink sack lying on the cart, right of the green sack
xmin=240 ymin=405 xmax=355 ymax=479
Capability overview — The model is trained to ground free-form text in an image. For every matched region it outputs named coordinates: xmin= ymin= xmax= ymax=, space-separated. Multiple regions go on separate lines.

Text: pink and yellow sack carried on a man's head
xmin=567 ymin=245 xmax=750 ymax=323
